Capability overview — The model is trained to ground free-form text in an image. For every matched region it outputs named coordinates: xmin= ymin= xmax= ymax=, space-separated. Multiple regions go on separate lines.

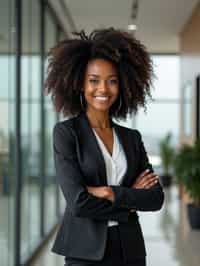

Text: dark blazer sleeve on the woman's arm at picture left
xmin=53 ymin=122 xmax=130 ymax=222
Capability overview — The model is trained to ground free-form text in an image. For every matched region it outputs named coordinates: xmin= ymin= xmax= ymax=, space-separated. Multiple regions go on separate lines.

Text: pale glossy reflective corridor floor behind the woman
xmin=31 ymin=186 xmax=200 ymax=266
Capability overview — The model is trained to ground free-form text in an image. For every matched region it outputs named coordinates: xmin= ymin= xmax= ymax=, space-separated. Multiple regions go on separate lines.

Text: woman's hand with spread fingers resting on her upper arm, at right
xmin=132 ymin=169 xmax=159 ymax=189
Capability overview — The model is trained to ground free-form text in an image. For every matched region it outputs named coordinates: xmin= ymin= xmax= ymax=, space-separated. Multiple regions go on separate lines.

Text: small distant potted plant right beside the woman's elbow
xmin=159 ymin=132 xmax=174 ymax=187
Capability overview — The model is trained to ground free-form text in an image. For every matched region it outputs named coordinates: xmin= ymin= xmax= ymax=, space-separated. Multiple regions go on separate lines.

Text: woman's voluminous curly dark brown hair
xmin=45 ymin=28 xmax=154 ymax=119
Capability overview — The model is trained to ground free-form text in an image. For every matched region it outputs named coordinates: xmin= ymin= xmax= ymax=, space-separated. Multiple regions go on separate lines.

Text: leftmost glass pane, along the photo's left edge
xmin=0 ymin=0 xmax=16 ymax=266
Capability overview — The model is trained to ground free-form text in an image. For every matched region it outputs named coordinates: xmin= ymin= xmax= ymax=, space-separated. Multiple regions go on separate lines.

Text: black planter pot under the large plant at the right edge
xmin=187 ymin=204 xmax=200 ymax=229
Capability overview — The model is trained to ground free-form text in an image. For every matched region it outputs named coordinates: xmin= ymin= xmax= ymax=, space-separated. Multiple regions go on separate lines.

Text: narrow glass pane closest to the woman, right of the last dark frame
xmin=44 ymin=7 xmax=58 ymax=232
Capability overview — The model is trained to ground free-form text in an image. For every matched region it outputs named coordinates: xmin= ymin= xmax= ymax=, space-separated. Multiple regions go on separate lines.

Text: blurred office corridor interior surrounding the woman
xmin=0 ymin=0 xmax=200 ymax=266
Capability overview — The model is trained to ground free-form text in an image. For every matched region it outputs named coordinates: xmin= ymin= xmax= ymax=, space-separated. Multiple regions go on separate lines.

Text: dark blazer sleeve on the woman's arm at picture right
xmin=111 ymin=130 xmax=164 ymax=211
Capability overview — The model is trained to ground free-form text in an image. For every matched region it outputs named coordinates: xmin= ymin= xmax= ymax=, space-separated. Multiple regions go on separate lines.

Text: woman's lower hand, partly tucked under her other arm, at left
xmin=87 ymin=186 xmax=114 ymax=201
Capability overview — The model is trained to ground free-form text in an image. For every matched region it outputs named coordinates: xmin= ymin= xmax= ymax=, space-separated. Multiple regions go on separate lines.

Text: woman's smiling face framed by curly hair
xmin=83 ymin=59 xmax=119 ymax=112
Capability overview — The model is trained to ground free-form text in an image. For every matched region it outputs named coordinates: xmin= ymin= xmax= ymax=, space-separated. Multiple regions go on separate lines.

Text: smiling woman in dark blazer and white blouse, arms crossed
xmin=46 ymin=28 xmax=164 ymax=266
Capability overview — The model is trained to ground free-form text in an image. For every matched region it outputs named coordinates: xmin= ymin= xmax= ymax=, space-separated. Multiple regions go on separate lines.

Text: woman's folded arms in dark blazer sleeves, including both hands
xmin=53 ymin=123 xmax=163 ymax=222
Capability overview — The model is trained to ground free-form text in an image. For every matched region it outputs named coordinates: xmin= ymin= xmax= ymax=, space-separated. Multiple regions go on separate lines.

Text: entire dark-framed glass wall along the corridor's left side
xmin=0 ymin=0 xmax=65 ymax=266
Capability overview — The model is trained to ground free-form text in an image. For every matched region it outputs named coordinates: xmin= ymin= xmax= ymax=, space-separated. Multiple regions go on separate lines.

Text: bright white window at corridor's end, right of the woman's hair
xmin=136 ymin=55 xmax=180 ymax=167
